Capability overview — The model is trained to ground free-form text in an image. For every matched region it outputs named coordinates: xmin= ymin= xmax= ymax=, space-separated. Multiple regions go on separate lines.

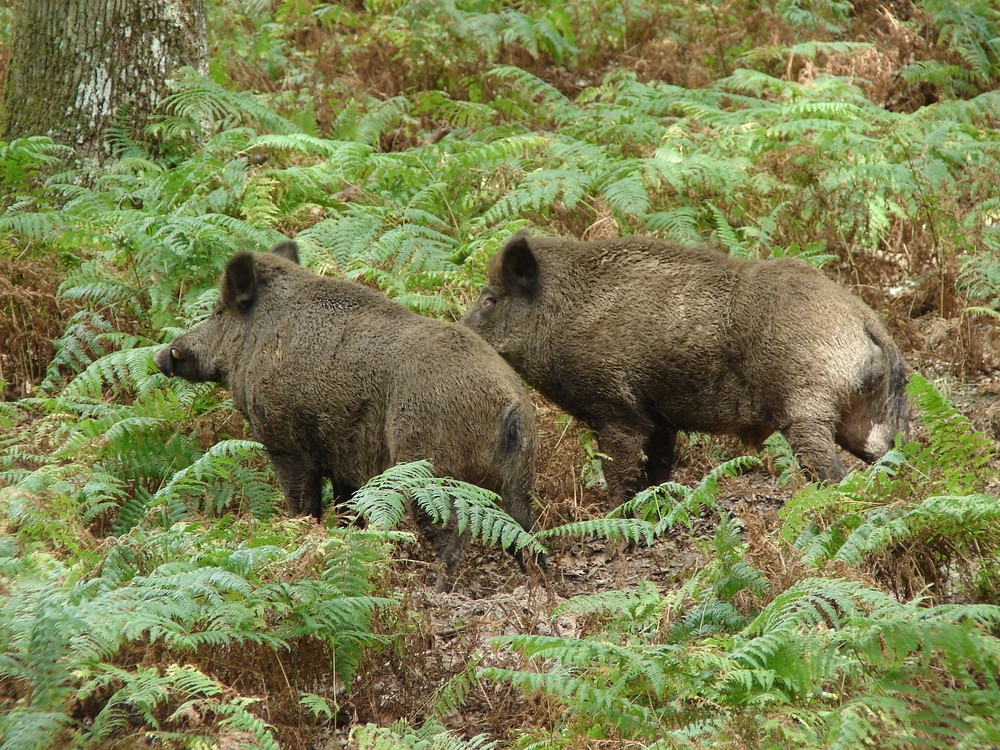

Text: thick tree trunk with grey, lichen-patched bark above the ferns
xmin=0 ymin=0 xmax=206 ymax=158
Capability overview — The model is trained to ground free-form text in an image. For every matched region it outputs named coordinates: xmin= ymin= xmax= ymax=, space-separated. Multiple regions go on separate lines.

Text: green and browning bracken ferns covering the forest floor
xmin=0 ymin=0 xmax=1000 ymax=750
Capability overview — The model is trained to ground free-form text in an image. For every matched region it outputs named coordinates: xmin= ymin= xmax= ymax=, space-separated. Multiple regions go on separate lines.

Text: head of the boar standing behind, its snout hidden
xmin=462 ymin=231 xmax=542 ymax=366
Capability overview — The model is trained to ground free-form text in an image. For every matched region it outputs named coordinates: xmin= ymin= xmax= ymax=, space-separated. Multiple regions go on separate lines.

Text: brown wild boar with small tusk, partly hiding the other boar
xmin=154 ymin=242 xmax=537 ymax=575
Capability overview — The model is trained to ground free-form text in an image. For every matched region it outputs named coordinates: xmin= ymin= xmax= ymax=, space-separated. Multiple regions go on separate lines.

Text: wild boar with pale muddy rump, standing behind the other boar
xmin=462 ymin=232 xmax=909 ymax=503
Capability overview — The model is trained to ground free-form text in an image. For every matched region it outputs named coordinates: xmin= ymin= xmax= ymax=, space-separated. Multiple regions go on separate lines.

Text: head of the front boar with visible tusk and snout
xmin=153 ymin=242 xmax=299 ymax=385
